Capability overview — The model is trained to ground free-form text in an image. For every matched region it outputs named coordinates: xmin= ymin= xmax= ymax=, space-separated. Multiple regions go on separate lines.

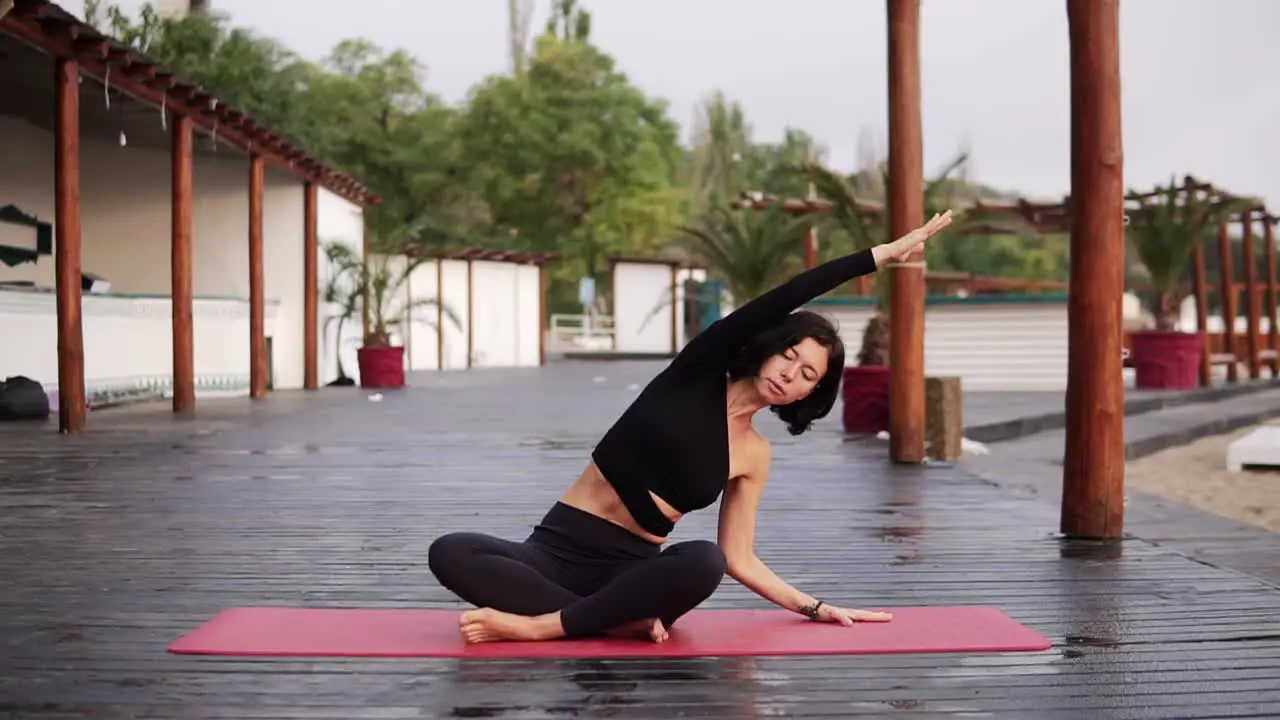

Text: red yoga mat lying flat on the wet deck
xmin=169 ymin=606 xmax=1050 ymax=657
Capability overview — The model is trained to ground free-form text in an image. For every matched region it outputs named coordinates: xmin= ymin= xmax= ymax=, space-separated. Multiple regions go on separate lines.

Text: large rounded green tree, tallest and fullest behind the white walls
xmin=460 ymin=23 xmax=681 ymax=304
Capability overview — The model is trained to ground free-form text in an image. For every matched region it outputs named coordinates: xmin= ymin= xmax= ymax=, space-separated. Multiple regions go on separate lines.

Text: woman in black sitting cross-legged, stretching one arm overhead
xmin=428 ymin=211 xmax=951 ymax=643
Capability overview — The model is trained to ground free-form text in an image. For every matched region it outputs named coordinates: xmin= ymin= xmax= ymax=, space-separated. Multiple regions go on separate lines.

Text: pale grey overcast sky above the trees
xmin=74 ymin=0 xmax=1280 ymax=209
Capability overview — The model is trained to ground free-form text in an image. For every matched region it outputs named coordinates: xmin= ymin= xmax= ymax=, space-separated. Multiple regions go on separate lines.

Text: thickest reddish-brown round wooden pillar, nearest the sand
xmin=1061 ymin=0 xmax=1125 ymax=539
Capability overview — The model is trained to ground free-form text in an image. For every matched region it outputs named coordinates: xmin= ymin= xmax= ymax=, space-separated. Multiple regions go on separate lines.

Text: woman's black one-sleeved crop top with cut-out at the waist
xmin=591 ymin=250 xmax=876 ymax=537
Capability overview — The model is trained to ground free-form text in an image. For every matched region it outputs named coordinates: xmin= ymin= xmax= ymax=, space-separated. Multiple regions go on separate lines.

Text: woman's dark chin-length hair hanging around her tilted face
xmin=728 ymin=310 xmax=845 ymax=436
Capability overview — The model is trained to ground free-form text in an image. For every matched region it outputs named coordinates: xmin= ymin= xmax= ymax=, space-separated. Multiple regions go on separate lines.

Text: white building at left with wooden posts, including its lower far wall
xmin=0 ymin=0 xmax=545 ymax=432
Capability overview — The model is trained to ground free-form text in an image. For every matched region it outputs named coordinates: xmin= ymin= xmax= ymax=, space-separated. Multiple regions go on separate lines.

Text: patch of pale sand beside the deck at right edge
xmin=1125 ymin=420 xmax=1280 ymax=532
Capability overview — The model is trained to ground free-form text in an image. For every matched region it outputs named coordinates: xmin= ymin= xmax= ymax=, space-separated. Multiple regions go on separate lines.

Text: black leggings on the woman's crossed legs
xmin=428 ymin=502 xmax=724 ymax=637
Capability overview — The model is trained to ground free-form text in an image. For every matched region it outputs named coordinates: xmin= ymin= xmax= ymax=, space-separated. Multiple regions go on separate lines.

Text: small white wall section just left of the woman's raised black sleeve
xmin=612 ymin=263 xmax=680 ymax=352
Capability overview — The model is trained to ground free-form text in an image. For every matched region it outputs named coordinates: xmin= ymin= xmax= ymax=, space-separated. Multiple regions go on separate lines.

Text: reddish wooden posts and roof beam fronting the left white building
xmin=0 ymin=0 xmax=380 ymax=433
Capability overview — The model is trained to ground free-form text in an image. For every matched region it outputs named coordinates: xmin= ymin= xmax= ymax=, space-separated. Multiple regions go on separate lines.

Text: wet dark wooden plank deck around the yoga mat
xmin=0 ymin=364 xmax=1280 ymax=720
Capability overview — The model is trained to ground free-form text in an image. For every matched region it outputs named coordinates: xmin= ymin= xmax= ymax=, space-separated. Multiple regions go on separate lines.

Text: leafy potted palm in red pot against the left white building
xmin=324 ymin=237 xmax=462 ymax=388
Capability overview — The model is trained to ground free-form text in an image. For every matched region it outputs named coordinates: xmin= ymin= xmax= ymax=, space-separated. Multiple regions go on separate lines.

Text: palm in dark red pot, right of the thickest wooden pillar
xmin=1125 ymin=181 xmax=1248 ymax=389
